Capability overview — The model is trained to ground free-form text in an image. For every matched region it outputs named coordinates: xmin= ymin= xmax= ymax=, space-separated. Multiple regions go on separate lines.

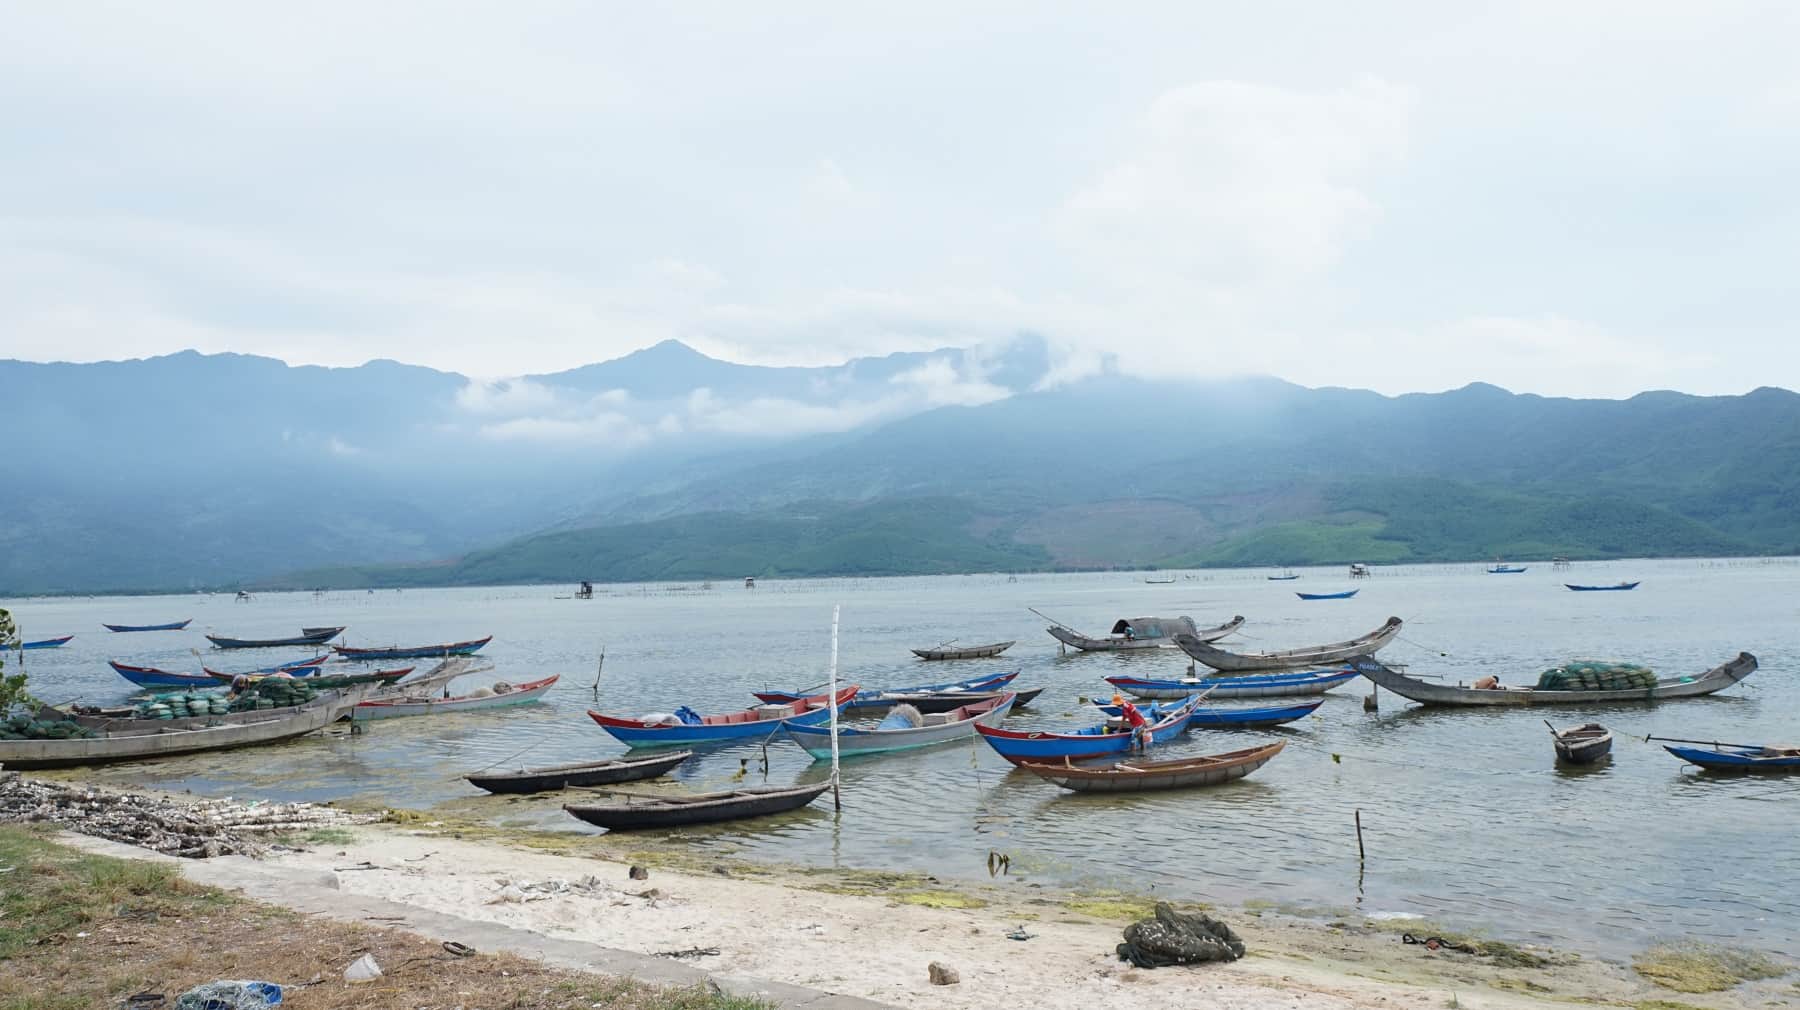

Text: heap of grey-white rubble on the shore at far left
xmin=0 ymin=771 xmax=376 ymax=859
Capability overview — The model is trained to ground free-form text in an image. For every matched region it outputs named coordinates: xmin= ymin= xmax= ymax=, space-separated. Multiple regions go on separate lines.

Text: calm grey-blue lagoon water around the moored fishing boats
xmin=0 ymin=560 xmax=1800 ymax=954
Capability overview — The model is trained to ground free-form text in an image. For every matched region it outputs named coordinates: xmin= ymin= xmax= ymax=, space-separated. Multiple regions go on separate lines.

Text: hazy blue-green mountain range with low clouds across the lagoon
xmin=0 ymin=335 xmax=1800 ymax=594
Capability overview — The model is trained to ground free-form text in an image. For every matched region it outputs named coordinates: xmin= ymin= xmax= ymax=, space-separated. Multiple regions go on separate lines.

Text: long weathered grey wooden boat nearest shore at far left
xmin=0 ymin=691 xmax=360 ymax=771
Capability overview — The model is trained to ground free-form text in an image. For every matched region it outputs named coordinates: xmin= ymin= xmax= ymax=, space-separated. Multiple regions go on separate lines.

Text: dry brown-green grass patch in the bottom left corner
xmin=0 ymin=825 xmax=772 ymax=1010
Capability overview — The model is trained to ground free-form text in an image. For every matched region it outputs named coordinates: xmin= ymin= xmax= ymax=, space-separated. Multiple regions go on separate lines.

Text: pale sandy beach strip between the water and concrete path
xmin=144 ymin=825 xmax=1751 ymax=1010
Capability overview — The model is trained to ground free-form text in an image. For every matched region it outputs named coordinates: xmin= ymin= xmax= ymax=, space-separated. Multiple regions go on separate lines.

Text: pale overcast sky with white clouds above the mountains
xmin=0 ymin=0 xmax=1800 ymax=396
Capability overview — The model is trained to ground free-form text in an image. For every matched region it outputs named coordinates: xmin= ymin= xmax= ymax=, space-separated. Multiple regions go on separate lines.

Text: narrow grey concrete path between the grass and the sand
xmin=59 ymin=832 xmax=893 ymax=1010
